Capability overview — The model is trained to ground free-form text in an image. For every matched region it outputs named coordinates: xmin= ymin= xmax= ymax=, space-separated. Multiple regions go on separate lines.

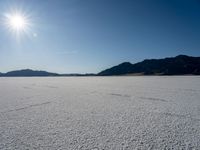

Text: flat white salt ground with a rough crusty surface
xmin=0 ymin=76 xmax=200 ymax=150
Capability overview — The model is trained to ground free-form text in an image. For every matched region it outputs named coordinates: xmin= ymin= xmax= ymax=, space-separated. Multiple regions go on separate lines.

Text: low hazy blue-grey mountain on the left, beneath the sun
xmin=0 ymin=69 xmax=59 ymax=77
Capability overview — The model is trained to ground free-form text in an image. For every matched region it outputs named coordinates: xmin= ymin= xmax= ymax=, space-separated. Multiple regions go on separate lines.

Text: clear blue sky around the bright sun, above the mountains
xmin=0 ymin=0 xmax=200 ymax=73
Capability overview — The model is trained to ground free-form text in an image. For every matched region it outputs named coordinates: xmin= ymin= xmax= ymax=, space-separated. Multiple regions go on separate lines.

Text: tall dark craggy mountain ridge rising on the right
xmin=98 ymin=55 xmax=200 ymax=76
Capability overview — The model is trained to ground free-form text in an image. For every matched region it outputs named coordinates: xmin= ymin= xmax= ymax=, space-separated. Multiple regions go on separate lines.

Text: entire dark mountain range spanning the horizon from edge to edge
xmin=0 ymin=55 xmax=200 ymax=77
